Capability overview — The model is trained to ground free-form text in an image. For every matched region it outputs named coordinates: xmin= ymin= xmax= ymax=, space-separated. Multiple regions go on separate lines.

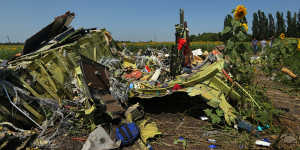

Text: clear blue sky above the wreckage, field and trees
xmin=0 ymin=0 xmax=300 ymax=42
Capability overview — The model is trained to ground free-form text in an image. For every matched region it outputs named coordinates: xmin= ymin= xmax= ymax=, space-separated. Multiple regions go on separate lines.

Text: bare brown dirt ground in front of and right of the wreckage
xmin=54 ymin=70 xmax=300 ymax=150
